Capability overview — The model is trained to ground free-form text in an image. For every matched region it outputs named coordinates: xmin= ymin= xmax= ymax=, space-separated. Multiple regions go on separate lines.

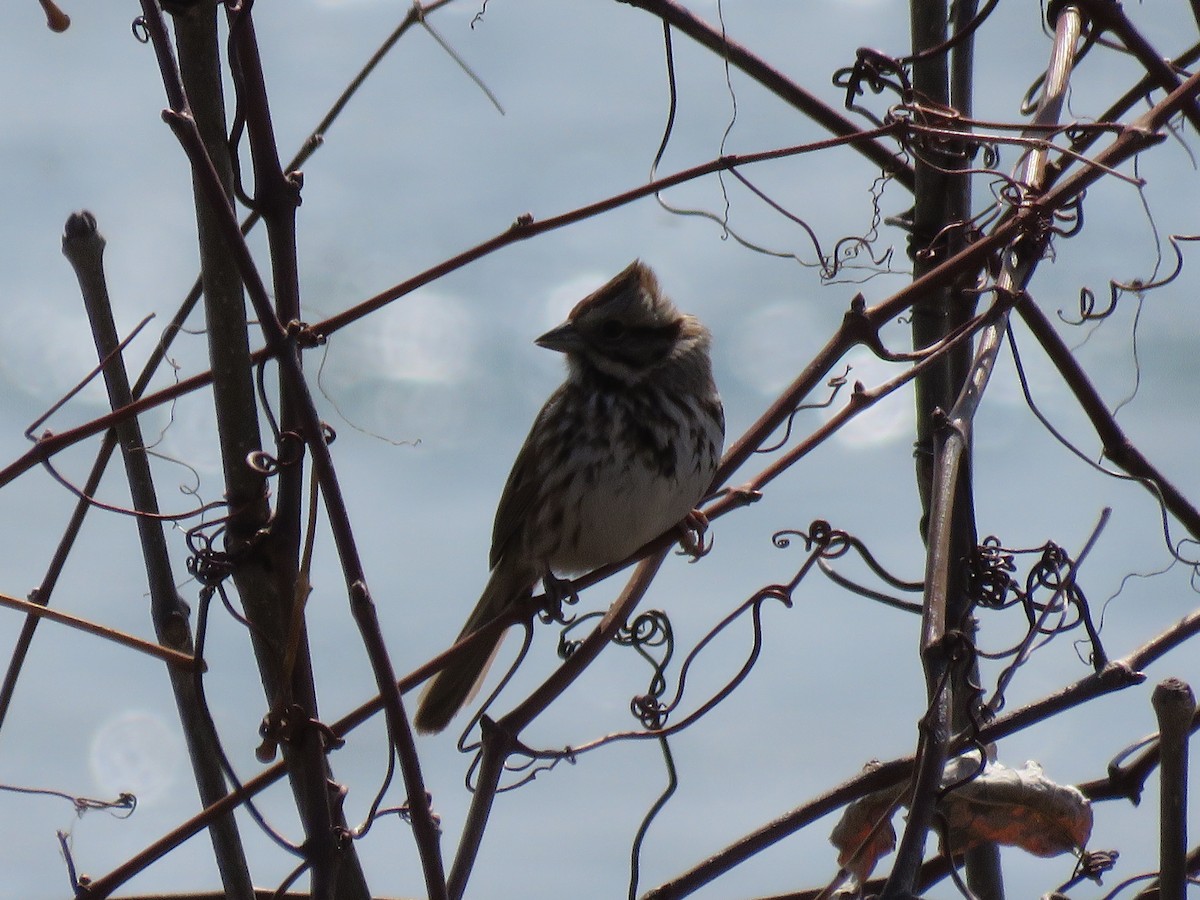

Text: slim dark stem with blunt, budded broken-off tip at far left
xmin=62 ymin=212 xmax=254 ymax=900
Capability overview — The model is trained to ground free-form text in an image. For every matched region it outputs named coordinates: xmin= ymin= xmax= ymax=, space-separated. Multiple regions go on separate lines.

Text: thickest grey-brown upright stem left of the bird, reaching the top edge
xmin=160 ymin=4 xmax=370 ymax=899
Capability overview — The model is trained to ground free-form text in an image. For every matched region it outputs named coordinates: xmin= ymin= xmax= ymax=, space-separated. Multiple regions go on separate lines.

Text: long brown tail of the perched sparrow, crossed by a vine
xmin=413 ymin=562 xmax=536 ymax=734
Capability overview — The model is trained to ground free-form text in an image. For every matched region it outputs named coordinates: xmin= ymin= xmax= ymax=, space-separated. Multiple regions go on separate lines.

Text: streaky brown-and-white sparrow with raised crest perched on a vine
xmin=414 ymin=260 xmax=725 ymax=732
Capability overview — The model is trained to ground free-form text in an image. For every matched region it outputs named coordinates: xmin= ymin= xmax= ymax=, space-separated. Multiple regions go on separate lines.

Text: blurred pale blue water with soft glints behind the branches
xmin=0 ymin=0 xmax=1200 ymax=900
